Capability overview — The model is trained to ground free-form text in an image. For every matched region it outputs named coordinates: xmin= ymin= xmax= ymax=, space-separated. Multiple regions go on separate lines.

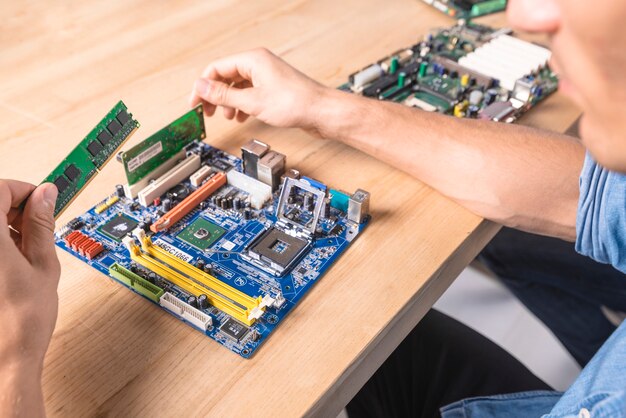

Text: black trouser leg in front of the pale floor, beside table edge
xmin=346 ymin=310 xmax=551 ymax=418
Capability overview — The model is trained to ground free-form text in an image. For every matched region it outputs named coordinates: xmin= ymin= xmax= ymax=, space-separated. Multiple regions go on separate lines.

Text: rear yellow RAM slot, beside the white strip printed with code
xmin=142 ymin=237 xmax=262 ymax=310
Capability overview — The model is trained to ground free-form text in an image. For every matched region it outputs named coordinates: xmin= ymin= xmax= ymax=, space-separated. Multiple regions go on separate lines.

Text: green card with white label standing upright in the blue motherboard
xmin=122 ymin=105 xmax=205 ymax=186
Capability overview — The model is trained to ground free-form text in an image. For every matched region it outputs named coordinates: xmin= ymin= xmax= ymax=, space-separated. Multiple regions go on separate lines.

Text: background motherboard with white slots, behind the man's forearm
xmin=339 ymin=23 xmax=558 ymax=123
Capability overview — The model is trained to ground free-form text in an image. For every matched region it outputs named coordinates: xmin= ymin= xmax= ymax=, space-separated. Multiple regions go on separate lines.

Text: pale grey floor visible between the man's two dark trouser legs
xmin=337 ymin=267 xmax=580 ymax=418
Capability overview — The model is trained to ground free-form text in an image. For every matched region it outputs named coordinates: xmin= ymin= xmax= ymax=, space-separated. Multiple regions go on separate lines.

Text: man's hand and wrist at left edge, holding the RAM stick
xmin=0 ymin=180 xmax=61 ymax=416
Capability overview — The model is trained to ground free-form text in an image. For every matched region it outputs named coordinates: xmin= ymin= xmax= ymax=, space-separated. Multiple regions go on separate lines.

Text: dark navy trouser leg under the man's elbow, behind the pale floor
xmin=478 ymin=228 xmax=626 ymax=366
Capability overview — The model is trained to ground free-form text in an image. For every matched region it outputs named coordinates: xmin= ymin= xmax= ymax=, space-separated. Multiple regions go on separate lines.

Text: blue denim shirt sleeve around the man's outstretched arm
xmin=576 ymin=154 xmax=626 ymax=273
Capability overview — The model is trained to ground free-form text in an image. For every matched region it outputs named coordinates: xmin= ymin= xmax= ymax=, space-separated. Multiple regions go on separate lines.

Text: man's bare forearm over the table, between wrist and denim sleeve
xmin=317 ymin=91 xmax=584 ymax=240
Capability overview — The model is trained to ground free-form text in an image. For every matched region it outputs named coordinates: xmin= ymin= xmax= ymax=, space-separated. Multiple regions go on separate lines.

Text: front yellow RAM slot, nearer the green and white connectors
xmin=130 ymin=245 xmax=255 ymax=325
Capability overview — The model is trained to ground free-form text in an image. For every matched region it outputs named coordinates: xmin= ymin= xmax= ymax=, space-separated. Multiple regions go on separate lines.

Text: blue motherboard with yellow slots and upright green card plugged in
xmin=56 ymin=106 xmax=370 ymax=358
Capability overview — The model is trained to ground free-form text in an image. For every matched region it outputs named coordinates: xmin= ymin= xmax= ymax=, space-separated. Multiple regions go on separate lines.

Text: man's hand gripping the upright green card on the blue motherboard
xmin=191 ymin=48 xmax=329 ymax=136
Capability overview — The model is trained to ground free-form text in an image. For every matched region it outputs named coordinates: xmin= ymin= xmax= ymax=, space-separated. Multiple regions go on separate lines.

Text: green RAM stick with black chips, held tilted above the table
xmin=43 ymin=101 xmax=139 ymax=218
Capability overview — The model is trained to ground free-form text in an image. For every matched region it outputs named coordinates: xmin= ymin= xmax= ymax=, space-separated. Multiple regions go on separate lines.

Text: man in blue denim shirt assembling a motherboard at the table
xmin=0 ymin=0 xmax=626 ymax=418
